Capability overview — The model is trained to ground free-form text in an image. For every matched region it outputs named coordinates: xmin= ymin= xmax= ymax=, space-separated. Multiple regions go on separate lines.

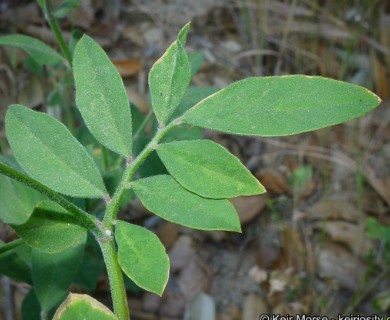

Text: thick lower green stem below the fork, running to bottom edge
xmin=99 ymin=239 xmax=130 ymax=320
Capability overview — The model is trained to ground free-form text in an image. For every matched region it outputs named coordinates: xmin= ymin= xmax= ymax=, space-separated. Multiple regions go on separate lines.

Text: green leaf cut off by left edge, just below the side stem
xmin=0 ymin=175 xmax=46 ymax=225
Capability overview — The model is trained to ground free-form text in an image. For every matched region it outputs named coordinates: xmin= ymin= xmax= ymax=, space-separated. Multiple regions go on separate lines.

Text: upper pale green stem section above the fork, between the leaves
xmin=103 ymin=121 xmax=178 ymax=230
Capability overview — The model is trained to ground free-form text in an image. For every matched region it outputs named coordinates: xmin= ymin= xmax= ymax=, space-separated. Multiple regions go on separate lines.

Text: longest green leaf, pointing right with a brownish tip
xmin=182 ymin=75 xmax=381 ymax=136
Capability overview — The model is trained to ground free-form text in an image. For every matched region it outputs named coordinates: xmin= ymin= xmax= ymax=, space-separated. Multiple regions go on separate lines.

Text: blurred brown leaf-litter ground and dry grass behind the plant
xmin=0 ymin=0 xmax=390 ymax=320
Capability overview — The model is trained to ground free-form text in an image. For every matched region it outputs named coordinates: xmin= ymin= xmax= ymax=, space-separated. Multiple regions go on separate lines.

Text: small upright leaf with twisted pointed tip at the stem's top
xmin=149 ymin=24 xmax=191 ymax=124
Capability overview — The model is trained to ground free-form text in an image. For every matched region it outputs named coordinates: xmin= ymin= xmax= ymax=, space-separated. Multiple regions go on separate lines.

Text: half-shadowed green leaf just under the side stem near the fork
xmin=13 ymin=201 xmax=87 ymax=253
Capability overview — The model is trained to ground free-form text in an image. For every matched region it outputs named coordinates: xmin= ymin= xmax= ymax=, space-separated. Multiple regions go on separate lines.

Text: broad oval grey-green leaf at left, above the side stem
xmin=5 ymin=105 xmax=106 ymax=198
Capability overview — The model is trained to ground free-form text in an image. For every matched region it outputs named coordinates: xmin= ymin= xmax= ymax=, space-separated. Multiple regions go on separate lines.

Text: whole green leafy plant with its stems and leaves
xmin=0 ymin=1 xmax=380 ymax=320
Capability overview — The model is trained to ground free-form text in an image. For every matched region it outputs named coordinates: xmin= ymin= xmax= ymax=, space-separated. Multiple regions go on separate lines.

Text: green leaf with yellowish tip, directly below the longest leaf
xmin=157 ymin=140 xmax=265 ymax=198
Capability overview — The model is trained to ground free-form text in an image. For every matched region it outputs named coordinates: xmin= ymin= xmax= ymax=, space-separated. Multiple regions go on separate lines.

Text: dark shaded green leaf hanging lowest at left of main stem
xmin=32 ymin=244 xmax=84 ymax=311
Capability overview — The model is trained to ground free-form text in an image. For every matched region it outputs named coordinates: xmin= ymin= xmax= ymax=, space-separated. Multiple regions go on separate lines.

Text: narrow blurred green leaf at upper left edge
xmin=0 ymin=34 xmax=63 ymax=65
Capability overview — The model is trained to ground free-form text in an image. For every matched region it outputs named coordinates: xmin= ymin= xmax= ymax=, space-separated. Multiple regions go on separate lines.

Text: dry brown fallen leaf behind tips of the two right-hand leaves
xmin=231 ymin=195 xmax=266 ymax=225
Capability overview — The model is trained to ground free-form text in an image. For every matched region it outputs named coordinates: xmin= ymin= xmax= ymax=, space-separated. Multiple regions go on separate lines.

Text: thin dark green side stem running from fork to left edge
xmin=0 ymin=162 xmax=105 ymax=238
